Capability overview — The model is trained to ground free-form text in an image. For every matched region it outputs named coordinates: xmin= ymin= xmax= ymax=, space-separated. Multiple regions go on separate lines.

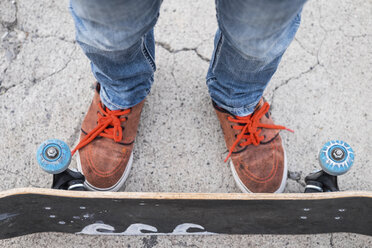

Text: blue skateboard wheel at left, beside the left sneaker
xmin=36 ymin=139 xmax=71 ymax=174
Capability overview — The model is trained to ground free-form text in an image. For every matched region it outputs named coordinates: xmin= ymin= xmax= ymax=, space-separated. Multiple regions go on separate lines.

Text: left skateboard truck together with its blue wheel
xmin=36 ymin=139 xmax=85 ymax=191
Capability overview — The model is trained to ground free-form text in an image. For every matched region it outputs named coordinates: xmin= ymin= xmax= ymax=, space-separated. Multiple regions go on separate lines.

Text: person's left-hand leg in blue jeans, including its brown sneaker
xmin=70 ymin=0 xmax=162 ymax=191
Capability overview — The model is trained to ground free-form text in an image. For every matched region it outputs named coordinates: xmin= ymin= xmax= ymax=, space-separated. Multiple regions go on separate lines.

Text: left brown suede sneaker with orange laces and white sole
xmin=72 ymin=84 xmax=145 ymax=191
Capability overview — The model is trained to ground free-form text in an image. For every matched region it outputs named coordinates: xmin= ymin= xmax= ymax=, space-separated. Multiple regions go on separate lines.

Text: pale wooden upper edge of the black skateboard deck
xmin=0 ymin=188 xmax=372 ymax=200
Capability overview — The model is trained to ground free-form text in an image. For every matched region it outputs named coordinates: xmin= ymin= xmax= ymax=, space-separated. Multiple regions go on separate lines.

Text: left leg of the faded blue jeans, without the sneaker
xmin=70 ymin=0 xmax=162 ymax=110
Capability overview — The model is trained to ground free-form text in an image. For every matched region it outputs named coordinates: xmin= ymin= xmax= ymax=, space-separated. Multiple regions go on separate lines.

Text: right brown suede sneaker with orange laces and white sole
xmin=213 ymin=99 xmax=293 ymax=193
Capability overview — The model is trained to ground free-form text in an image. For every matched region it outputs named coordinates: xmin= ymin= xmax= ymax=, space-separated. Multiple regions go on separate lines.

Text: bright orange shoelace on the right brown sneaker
xmin=225 ymin=102 xmax=294 ymax=162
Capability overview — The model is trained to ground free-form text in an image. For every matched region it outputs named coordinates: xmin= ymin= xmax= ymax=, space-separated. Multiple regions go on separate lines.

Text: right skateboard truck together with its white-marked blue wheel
xmin=305 ymin=140 xmax=354 ymax=193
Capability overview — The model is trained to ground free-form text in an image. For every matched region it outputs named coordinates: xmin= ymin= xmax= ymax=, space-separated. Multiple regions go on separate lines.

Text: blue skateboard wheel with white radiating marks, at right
xmin=319 ymin=140 xmax=354 ymax=176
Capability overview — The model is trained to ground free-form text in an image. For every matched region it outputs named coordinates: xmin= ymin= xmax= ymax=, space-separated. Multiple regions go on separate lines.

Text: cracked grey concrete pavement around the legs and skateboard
xmin=0 ymin=0 xmax=372 ymax=247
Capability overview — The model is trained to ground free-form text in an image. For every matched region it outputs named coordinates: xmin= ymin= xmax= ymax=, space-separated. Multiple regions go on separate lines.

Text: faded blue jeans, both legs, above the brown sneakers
xmin=70 ymin=0 xmax=306 ymax=116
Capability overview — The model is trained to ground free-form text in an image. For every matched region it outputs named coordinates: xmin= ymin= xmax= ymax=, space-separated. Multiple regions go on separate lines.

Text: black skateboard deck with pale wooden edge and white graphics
xmin=0 ymin=188 xmax=372 ymax=239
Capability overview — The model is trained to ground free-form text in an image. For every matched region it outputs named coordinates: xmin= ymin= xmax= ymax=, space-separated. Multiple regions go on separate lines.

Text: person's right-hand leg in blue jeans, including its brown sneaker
xmin=207 ymin=0 xmax=306 ymax=192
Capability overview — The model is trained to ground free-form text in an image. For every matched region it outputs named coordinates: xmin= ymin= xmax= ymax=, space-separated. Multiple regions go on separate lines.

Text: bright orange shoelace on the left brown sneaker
xmin=71 ymin=104 xmax=131 ymax=156
